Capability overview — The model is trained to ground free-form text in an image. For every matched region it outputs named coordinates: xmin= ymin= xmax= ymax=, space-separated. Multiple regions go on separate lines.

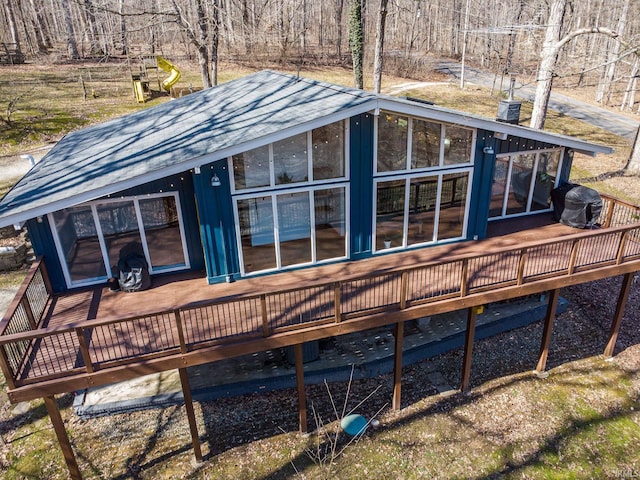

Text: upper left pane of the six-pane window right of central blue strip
xmin=378 ymin=113 xmax=409 ymax=172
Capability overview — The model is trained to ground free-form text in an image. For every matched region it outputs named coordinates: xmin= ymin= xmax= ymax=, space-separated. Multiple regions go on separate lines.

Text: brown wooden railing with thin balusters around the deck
xmin=0 ymin=200 xmax=640 ymax=388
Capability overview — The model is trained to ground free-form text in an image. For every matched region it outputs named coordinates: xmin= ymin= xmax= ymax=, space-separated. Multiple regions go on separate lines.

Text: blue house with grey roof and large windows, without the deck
xmin=0 ymin=71 xmax=611 ymax=292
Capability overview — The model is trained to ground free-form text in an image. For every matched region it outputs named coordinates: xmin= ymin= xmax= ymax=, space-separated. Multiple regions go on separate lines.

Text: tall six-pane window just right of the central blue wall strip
xmin=373 ymin=112 xmax=475 ymax=251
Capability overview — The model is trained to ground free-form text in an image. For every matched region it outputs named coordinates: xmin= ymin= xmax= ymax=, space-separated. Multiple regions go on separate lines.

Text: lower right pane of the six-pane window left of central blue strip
xmin=313 ymin=188 xmax=346 ymax=261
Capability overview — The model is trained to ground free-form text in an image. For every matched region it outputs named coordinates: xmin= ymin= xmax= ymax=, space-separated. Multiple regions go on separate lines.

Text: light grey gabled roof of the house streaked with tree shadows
xmin=0 ymin=70 xmax=611 ymax=226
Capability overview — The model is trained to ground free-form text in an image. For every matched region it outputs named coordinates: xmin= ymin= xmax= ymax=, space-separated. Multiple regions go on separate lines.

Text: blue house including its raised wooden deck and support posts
xmin=0 ymin=71 xmax=640 ymax=478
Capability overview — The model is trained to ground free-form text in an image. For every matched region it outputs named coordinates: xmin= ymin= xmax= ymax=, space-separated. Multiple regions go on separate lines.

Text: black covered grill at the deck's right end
xmin=551 ymin=183 xmax=602 ymax=228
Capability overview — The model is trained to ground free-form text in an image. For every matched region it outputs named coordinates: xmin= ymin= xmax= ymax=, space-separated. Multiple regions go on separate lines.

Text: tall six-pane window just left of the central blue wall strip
xmin=229 ymin=122 xmax=348 ymax=275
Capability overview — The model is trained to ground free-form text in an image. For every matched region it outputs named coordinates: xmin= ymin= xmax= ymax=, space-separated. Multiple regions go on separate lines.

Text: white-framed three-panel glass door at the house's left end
xmin=49 ymin=193 xmax=189 ymax=286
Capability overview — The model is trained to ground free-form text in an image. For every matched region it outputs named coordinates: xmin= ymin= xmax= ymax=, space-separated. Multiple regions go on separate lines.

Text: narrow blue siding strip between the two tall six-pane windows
xmin=349 ymin=113 xmax=375 ymax=259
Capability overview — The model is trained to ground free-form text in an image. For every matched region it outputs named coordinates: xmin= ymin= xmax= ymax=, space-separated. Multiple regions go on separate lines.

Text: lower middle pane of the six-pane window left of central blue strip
xmin=277 ymin=192 xmax=311 ymax=267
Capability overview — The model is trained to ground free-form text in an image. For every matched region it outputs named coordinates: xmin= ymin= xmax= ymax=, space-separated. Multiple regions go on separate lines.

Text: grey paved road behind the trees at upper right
xmin=437 ymin=61 xmax=640 ymax=140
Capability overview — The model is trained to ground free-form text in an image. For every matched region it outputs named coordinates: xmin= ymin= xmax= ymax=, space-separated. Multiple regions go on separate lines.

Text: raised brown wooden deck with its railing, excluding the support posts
xmin=0 ymin=195 xmax=640 ymax=401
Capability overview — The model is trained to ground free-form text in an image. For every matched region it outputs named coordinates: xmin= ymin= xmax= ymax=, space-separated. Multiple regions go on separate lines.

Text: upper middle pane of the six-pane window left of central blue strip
xmin=273 ymin=133 xmax=309 ymax=185
